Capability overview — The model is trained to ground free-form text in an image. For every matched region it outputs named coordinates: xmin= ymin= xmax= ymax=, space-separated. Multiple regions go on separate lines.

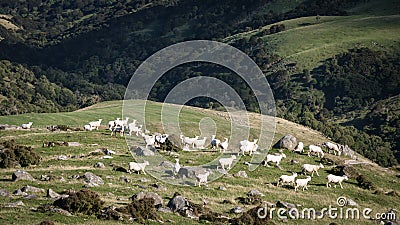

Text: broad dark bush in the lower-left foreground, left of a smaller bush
xmin=53 ymin=189 xmax=104 ymax=215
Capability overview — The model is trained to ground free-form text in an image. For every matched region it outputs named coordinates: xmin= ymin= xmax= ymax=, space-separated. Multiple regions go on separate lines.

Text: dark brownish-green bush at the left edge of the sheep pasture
xmin=0 ymin=140 xmax=40 ymax=168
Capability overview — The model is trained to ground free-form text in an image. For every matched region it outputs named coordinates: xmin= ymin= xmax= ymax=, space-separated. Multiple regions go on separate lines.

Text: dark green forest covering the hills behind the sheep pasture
xmin=0 ymin=0 xmax=400 ymax=166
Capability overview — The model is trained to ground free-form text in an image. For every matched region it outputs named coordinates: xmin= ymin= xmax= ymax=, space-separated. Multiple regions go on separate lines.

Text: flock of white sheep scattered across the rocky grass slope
xmin=84 ymin=118 xmax=348 ymax=188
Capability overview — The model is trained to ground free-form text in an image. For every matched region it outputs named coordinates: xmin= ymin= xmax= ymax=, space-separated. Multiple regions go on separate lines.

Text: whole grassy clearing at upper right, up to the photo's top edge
xmin=223 ymin=0 xmax=400 ymax=69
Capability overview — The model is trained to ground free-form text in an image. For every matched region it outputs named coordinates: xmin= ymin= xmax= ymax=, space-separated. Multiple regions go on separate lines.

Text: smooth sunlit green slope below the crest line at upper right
xmin=263 ymin=15 xmax=400 ymax=69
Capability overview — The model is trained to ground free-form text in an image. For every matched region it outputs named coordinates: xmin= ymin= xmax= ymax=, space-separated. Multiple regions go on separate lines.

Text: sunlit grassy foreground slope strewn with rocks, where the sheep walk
xmin=0 ymin=101 xmax=400 ymax=224
